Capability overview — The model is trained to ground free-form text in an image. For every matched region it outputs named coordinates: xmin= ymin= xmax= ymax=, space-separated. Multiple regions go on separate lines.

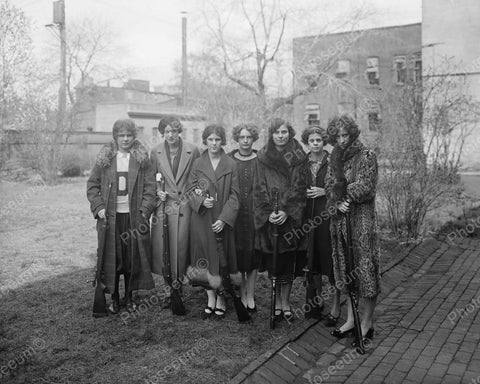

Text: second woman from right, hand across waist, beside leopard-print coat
xmin=302 ymin=126 xmax=340 ymax=326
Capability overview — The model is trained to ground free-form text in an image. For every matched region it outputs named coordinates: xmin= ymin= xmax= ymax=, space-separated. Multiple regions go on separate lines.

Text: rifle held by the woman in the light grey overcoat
xmin=156 ymin=173 xmax=187 ymax=316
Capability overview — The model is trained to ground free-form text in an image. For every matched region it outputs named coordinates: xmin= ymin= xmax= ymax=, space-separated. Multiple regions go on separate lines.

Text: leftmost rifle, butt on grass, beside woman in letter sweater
xmin=92 ymin=183 xmax=112 ymax=318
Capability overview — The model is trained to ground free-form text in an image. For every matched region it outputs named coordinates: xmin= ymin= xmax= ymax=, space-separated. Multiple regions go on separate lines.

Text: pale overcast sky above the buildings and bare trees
xmin=14 ymin=0 xmax=421 ymax=84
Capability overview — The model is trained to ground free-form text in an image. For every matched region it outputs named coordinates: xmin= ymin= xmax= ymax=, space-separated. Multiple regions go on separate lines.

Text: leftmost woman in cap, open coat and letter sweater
xmin=87 ymin=119 xmax=155 ymax=313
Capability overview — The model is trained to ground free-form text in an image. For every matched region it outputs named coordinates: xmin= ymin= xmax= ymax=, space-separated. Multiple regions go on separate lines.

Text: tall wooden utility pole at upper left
xmin=53 ymin=0 xmax=67 ymax=133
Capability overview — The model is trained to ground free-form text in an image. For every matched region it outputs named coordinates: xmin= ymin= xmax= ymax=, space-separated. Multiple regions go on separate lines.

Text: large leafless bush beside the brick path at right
xmin=379 ymin=60 xmax=479 ymax=238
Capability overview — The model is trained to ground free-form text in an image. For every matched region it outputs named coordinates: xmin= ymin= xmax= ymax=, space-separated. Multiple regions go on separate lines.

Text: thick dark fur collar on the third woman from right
xmin=258 ymin=139 xmax=307 ymax=174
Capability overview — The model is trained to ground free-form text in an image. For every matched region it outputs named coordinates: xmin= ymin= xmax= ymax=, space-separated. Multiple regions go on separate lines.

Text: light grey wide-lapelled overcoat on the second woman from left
xmin=150 ymin=139 xmax=200 ymax=280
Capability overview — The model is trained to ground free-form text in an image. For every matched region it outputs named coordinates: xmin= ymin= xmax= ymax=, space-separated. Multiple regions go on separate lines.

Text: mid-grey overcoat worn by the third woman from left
xmin=189 ymin=151 xmax=239 ymax=284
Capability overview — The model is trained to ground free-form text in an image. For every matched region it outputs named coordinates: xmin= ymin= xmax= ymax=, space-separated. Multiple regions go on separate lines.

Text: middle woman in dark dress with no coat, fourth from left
xmin=229 ymin=124 xmax=259 ymax=312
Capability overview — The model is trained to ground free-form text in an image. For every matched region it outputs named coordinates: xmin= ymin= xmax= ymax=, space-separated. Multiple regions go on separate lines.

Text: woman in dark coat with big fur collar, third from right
xmin=254 ymin=118 xmax=306 ymax=321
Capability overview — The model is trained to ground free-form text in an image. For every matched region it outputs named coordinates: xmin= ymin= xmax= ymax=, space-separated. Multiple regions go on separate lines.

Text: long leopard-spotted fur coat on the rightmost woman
xmin=325 ymin=139 xmax=380 ymax=298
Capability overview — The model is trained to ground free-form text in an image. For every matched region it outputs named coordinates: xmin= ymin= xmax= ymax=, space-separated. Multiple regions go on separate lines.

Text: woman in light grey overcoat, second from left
xmin=150 ymin=116 xmax=200 ymax=290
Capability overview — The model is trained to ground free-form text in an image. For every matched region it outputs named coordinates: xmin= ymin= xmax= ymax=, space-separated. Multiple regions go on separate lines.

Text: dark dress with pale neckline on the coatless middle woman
xmin=229 ymin=150 xmax=260 ymax=272
